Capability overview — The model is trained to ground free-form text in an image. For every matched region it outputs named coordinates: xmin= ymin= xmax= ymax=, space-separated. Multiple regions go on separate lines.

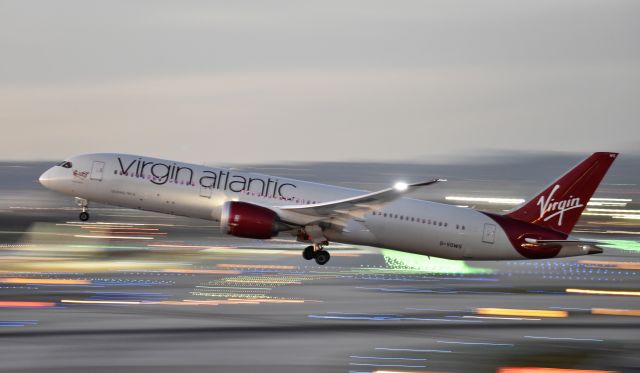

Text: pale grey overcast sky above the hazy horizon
xmin=0 ymin=0 xmax=640 ymax=163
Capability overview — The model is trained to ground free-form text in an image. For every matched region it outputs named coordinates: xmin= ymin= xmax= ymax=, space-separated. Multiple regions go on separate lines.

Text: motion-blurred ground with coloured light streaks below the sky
xmin=0 ymin=156 xmax=640 ymax=372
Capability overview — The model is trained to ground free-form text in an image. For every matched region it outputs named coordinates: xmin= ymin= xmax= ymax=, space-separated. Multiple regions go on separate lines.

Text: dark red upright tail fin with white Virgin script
xmin=507 ymin=152 xmax=618 ymax=234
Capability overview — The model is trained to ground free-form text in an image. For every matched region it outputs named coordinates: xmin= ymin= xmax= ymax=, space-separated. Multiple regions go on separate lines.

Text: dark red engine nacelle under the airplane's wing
xmin=220 ymin=201 xmax=286 ymax=239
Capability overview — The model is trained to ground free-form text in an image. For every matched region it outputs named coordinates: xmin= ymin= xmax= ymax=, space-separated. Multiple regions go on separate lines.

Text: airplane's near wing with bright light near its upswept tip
xmin=278 ymin=179 xmax=445 ymax=221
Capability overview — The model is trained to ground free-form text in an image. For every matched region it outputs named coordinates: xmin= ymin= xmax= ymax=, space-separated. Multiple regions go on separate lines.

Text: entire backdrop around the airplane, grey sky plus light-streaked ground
xmin=0 ymin=0 xmax=640 ymax=372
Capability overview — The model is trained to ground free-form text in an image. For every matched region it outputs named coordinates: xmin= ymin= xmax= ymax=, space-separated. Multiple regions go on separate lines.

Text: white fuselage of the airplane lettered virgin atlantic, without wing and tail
xmin=40 ymin=153 xmax=588 ymax=260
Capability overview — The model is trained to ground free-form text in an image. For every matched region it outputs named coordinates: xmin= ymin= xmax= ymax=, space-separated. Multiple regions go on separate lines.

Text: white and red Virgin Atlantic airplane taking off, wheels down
xmin=39 ymin=152 xmax=618 ymax=265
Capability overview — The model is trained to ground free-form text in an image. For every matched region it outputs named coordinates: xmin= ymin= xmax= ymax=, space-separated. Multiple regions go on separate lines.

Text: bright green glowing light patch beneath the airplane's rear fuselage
xmin=382 ymin=249 xmax=493 ymax=275
